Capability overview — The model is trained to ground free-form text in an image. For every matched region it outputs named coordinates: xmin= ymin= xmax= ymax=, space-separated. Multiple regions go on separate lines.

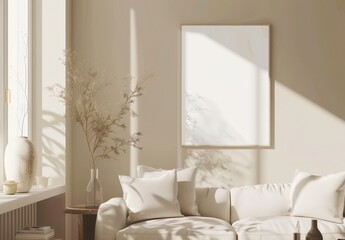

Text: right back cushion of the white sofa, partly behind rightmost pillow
xmin=230 ymin=184 xmax=291 ymax=223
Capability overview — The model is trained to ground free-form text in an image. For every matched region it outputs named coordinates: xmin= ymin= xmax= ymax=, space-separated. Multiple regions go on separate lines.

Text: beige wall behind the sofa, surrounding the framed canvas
xmin=72 ymin=0 xmax=345 ymax=203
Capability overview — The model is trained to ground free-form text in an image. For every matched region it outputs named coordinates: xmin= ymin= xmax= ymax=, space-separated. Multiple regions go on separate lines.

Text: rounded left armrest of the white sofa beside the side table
xmin=95 ymin=197 xmax=127 ymax=240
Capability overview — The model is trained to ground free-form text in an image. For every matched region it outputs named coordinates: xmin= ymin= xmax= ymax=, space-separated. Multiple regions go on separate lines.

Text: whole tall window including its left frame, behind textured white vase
xmin=0 ymin=0 xmax=31 ymax=183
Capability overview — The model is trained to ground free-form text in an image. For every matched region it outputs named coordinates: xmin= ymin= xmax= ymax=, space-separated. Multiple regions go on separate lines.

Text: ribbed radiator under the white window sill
xmin=0 ymin=203 xmax=37 ymax=240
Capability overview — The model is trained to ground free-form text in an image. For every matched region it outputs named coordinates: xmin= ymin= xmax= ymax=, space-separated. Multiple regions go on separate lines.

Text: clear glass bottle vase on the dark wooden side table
xmin=85 ymin=168 xmax=103 ymax=207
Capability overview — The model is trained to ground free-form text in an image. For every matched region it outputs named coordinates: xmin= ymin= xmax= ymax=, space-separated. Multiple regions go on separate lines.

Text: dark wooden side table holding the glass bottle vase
xmin=64 ymin=205 xmax=98 ymax=240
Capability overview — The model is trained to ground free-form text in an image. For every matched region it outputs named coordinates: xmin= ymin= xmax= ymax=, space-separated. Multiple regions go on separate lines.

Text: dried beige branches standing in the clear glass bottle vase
xmin=48 ymin=51 xmax=146 ymax=206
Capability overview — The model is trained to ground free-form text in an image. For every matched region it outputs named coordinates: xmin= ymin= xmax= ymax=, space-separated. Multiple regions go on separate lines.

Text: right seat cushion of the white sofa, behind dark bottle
xmin=232 ymin=216 xmax=345 ymax=240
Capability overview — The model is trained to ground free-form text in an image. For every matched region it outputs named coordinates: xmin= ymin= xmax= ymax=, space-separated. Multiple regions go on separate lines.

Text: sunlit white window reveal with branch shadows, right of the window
xmin=38 ymin=1 xmax=66 ymax=185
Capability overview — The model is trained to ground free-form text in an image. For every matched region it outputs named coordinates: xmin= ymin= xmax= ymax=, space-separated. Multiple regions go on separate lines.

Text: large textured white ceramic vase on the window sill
xmin=4 ymin=137 xmax=36 ymax=192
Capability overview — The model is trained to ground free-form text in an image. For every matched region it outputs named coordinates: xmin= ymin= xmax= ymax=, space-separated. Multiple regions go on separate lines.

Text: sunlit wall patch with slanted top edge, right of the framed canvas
xmin=260 ymin=82 xmax=345 ymax=182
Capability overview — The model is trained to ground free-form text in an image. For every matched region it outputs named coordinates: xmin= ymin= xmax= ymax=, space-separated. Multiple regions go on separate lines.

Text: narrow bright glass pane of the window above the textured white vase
xmin=7 ymin=0 xmax=31 ymax=138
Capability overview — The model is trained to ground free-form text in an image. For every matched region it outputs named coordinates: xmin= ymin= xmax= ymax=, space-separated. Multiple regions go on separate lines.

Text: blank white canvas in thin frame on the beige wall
xmin=181 ymin=25 xmax=270 ymax=148
